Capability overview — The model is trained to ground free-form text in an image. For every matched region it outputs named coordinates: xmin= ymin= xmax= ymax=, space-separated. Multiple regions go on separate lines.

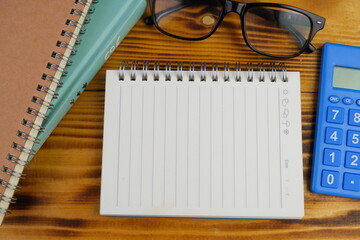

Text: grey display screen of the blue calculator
xmin=333 ymin=67 xmax=360 ymax=90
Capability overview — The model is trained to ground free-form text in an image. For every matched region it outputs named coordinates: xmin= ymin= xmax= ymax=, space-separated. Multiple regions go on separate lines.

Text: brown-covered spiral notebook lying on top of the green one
xmin=0 ymin=0 xmax=93 ymax=223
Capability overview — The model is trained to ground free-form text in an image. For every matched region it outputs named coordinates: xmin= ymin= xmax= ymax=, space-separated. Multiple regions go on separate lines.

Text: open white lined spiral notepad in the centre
xmin=100 ymin=63 xmax=304 ymax=219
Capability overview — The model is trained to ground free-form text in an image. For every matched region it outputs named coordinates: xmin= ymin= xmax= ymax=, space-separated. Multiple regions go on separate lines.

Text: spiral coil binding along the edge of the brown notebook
xmin=0 ymin=0 xmax=97 ymax=215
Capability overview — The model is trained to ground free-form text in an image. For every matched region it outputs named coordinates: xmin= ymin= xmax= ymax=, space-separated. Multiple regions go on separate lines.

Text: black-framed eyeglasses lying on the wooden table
xmin=145 ymin=0 xmax=325 ymax=58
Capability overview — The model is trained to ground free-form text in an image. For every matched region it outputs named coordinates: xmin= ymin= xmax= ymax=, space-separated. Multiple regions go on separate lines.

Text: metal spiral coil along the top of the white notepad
xmin=119 ymin=61 xmax=288 ymax=82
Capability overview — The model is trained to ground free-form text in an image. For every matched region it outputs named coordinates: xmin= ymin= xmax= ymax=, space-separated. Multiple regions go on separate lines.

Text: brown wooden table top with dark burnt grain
xmin=0 ymin=0 xmax=360 ymax=240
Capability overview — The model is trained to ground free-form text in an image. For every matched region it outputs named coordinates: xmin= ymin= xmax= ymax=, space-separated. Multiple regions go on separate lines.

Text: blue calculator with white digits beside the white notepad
xmin=311 ymin=43 xmax=360 ymax=198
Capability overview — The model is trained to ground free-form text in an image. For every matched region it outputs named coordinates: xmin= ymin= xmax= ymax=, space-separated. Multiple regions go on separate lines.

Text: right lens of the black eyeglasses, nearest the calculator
xmin=243 ymin=7 xmax=311 ymax=56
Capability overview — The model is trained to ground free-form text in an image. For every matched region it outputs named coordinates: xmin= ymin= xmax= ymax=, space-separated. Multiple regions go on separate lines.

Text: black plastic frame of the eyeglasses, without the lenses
xmin=144 ymin=0 xmax=326 ymax=58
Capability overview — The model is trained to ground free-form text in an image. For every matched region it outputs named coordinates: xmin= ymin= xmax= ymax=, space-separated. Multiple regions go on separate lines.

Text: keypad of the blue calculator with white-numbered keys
xmin=319 ymin=95 xmax=360 ymax=198
